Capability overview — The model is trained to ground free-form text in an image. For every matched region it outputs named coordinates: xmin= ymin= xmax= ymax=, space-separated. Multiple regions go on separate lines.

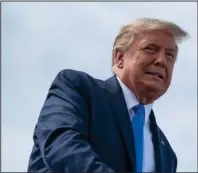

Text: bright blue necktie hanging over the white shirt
xmin=132 ymin=104 xmax=145 ymax=172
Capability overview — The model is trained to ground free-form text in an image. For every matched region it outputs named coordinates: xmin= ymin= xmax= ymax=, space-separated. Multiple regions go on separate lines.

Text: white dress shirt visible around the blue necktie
xmin=117 ymin=77 xmax=155 ymax=172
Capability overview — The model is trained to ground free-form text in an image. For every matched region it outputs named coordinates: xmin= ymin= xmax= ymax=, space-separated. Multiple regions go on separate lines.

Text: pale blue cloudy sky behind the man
xmin=1 ymin=2 xmax=197 ymax=172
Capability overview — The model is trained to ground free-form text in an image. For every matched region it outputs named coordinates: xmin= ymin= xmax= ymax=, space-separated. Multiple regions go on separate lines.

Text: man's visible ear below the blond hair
xmin=113 ymin=49 xmax=124 ymax=69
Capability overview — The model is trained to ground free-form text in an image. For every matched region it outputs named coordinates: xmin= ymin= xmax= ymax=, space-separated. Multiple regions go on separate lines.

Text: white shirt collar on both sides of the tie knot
xmin=116 ymin=76 xmax=153 ymax=124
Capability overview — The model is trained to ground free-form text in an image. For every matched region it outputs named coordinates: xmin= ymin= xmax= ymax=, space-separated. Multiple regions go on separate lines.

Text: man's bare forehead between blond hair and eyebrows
xmin=134 ymin=30 xmax=177 ymax=51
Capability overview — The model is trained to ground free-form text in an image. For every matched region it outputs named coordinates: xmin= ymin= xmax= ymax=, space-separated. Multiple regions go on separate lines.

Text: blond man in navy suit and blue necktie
xmin=28 ymin=19 xmax=187 ymax=172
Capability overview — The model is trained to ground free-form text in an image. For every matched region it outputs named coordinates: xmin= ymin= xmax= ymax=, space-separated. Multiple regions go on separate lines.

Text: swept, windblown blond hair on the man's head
xmin=112 ymin=18 xmax=189 ymax=66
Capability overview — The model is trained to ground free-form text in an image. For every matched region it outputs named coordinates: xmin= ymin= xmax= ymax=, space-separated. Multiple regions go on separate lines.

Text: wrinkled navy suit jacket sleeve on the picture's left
xmin=34 ymin=70 xmax=114 ymax=172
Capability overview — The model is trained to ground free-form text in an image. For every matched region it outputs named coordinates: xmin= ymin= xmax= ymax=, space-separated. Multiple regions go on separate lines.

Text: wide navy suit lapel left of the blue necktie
xmin=105 ymin=76 xmax=136 ymax=171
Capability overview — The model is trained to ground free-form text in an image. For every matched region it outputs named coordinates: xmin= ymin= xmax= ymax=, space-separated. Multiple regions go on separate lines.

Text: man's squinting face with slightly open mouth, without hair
xmin=116 ymin=30 xmax=177 ymax=102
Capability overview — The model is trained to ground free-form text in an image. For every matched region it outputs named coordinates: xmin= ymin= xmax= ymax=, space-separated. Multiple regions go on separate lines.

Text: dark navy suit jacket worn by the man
xmin=28 ymin=70 xmax=177 ymax=172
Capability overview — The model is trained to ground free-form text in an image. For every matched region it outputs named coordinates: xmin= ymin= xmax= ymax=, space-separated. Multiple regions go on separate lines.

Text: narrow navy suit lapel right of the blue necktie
xmin=149 ymin=110 xmax=165 ymax=172
